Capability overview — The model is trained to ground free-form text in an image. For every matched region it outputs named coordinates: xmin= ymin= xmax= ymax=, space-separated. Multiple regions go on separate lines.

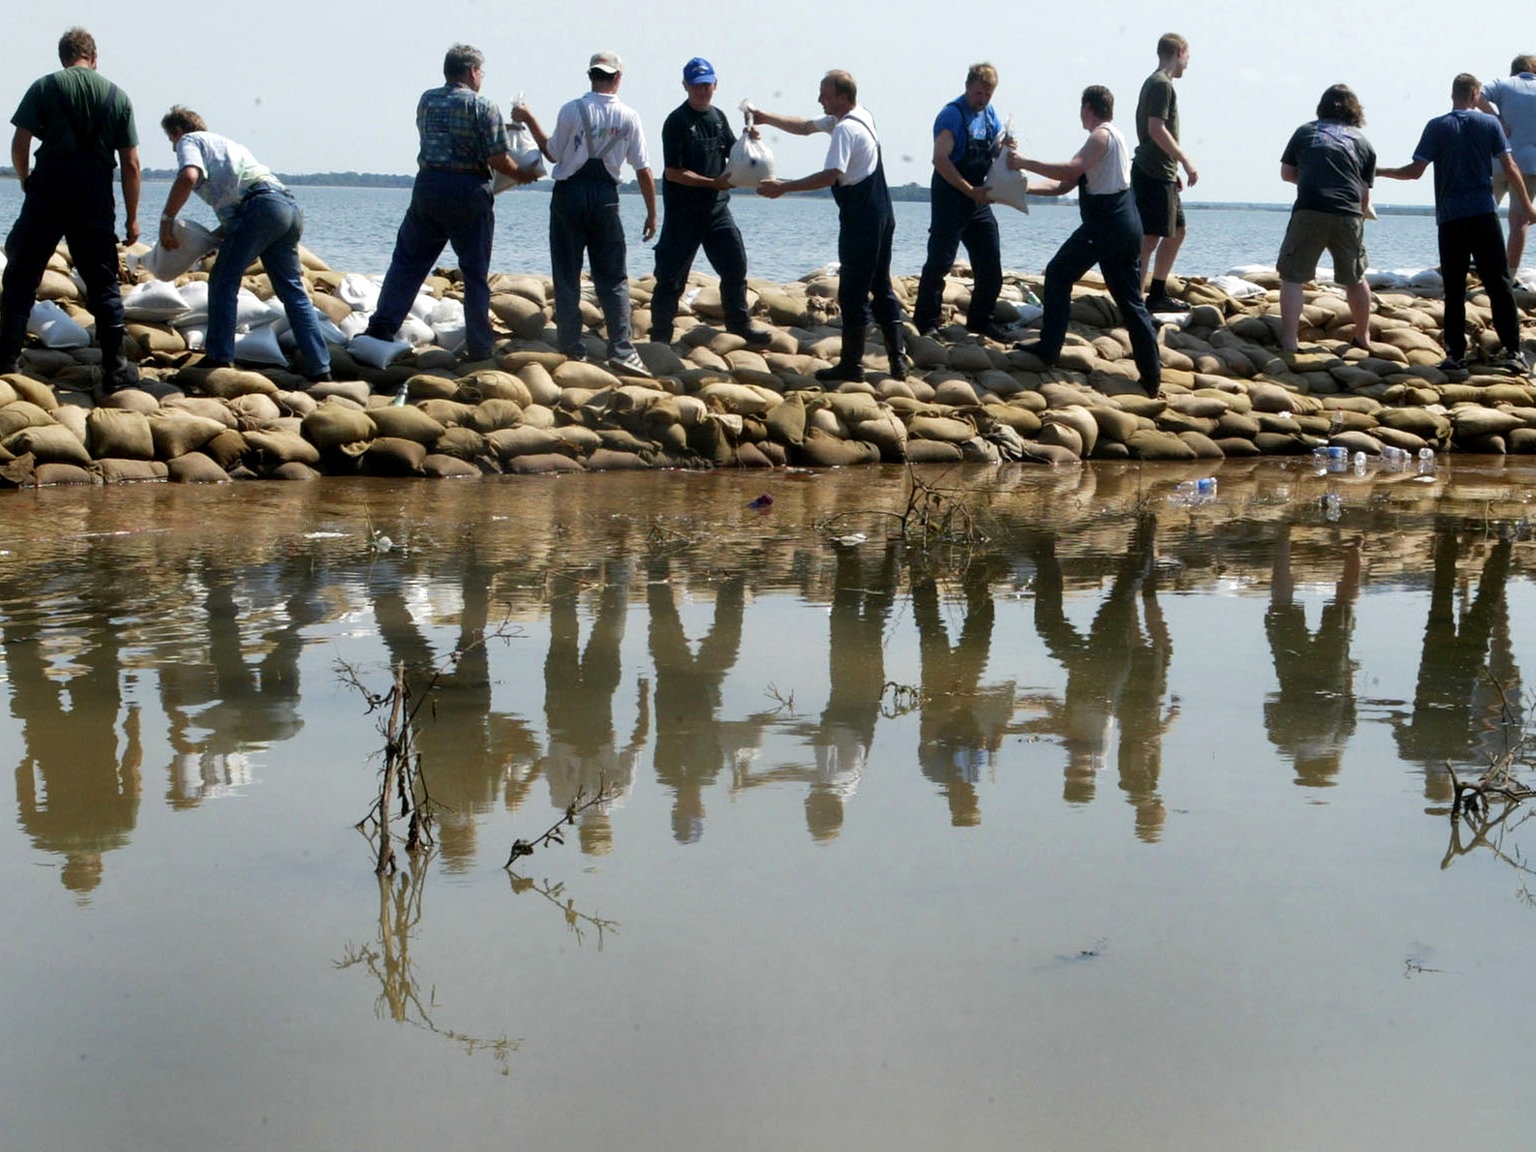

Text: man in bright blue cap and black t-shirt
xmin=650 ymin=57 xmax=773 ymax=347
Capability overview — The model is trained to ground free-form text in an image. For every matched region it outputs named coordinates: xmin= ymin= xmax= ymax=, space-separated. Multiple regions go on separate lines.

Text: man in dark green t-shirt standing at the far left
xmin=0 ymin=28 xmax=140 ymax=392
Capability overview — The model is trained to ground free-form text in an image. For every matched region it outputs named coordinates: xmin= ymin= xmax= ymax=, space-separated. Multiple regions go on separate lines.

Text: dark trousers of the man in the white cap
xmin=550 ymin=177 xmax=634 ymax=358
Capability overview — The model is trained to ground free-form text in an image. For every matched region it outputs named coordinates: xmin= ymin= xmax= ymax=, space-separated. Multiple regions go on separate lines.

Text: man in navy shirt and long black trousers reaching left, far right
xmin=1376 ymin=72 xmax=1536 ymax=376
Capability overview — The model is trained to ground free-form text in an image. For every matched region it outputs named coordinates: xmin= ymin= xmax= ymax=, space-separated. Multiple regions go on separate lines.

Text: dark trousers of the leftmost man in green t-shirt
xmin=0 ymin=155 xmax=123 ymax=372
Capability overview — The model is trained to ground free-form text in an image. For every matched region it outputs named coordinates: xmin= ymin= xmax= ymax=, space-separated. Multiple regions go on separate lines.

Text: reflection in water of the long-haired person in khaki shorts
xmin=1264 ymin=524 xmax=1364 ymax=788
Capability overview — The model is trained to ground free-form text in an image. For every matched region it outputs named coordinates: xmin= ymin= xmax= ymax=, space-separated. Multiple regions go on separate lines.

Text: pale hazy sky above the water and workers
xmin=0 ymin=0 xmax=1536 ymax=204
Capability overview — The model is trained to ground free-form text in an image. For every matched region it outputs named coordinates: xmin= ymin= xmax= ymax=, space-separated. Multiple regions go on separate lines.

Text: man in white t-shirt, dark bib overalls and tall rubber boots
xmin=753 ymin=71 xmax=906 ymax=384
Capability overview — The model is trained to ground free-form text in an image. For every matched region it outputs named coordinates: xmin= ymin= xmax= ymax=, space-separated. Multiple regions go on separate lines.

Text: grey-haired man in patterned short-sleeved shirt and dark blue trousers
xmin=367 ymin=45 xmax=533 ymax=361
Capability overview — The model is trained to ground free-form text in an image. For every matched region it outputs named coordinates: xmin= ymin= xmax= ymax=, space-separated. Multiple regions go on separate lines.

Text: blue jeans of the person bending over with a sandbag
xmin=204 ymin=186 xmax=330 ymax=376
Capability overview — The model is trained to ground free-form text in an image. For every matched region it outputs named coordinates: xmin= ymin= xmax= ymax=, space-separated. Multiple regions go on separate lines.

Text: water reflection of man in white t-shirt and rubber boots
xmin=805 ymin=547 xmax=897 ymax=840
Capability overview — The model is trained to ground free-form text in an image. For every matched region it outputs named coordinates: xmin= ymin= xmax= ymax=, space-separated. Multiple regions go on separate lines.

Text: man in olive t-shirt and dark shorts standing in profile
xmin=1130 ymin=32 xmax=1200 ymax=312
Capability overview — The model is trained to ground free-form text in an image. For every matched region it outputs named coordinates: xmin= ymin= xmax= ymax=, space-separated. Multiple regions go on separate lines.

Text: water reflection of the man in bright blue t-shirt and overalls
xmin=912 ymin=561 xmax=1014 ymax=828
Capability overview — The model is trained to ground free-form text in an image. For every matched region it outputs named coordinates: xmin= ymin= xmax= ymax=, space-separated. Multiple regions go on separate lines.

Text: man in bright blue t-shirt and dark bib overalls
xmin=912 ymin=65 xmax=1008 ymax=341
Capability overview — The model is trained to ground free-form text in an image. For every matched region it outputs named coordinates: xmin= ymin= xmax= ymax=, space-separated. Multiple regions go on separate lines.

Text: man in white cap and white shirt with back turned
xmin=524 ymin=52 xmax=656 ymax=376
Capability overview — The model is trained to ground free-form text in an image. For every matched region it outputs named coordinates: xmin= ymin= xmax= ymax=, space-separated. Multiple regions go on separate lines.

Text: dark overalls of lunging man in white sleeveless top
xmin=1040 ymin=192 xmax=1163 ymax=395
